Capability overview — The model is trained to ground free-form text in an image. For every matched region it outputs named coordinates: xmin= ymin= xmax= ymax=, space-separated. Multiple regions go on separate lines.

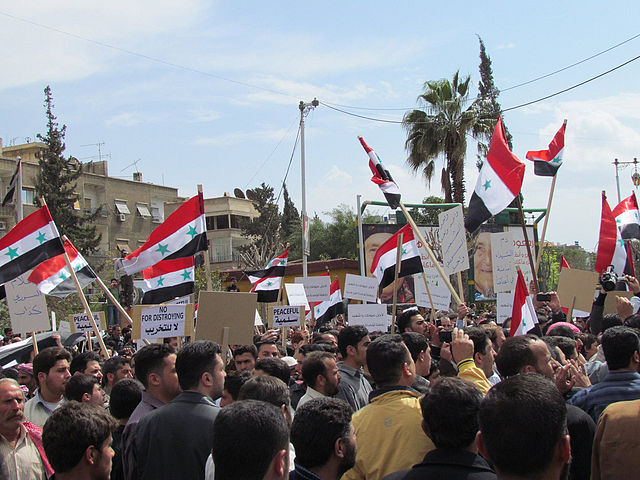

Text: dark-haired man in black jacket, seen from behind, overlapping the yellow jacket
xmin=384 ymin=377 xmax=496 ymax=480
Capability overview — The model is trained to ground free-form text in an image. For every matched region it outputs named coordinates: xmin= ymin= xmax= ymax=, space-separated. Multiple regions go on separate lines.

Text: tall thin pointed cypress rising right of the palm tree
xmin=476 ymin=35 xmax=513 ymax=170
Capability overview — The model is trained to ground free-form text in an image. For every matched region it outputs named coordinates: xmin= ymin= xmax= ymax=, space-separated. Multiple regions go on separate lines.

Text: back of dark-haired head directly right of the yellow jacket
xmin=420 ymin=377 xmax=482 ymax=450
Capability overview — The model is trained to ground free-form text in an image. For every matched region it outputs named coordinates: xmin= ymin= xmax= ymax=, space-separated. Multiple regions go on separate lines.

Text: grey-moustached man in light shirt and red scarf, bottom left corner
xmin=0 ymin=378 xmax=53 ymax=480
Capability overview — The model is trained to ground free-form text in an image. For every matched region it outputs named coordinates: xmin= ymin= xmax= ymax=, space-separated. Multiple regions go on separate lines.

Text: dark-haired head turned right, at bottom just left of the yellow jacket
xmin=289 ymin=397 xmax=356 ymax=480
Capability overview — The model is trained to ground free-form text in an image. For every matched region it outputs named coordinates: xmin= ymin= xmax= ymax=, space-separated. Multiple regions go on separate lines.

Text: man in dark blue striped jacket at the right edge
xmin=569 ymin=327 xmax=640 ymax=422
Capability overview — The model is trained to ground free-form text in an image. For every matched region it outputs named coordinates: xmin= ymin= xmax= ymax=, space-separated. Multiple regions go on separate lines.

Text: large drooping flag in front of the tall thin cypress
xmin=464 ymin=118 xmax=525 ymax=233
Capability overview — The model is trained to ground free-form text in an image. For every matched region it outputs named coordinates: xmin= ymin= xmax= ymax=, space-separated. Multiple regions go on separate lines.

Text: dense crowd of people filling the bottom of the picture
xmin=0 ymin=277 xmax=640 ymax=480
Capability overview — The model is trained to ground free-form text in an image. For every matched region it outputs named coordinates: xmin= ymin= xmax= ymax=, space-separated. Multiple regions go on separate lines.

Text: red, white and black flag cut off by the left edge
xmin=0 ymin=205 xmax=64 ymax=285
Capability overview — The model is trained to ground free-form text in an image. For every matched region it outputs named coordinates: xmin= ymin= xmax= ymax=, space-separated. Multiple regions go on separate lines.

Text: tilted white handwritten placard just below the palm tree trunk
xmin=438 ymin=205 xmax=469 ymax=275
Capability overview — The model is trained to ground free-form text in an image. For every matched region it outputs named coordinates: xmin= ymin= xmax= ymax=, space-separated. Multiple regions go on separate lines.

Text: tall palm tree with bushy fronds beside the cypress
xmin=402 ymin=72 xmax=495 ymax=204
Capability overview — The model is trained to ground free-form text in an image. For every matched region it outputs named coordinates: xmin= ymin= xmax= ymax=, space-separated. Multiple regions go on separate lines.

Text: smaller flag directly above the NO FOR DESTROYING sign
xmin=142 ymin=257 xmax=195 ymax=305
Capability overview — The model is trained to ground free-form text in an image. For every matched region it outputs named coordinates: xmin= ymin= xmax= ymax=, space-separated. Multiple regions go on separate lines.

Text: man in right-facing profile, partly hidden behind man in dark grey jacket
xmin=122 ymin=343 xmax=180 ymax=480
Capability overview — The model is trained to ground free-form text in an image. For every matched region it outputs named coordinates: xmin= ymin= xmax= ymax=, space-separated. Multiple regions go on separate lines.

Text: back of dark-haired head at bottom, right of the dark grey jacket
xmin=211 ymin=400 xmax=289 ymax=480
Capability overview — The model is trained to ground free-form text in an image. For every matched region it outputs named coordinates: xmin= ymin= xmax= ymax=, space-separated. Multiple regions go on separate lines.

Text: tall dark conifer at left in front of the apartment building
xmin=35 ymin=86 xmax=102 ymax=255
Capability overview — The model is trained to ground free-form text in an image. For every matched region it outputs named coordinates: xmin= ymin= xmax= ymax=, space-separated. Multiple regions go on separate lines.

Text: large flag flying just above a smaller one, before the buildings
xmin=118 ymin=192 xmax=207 ymax=275
